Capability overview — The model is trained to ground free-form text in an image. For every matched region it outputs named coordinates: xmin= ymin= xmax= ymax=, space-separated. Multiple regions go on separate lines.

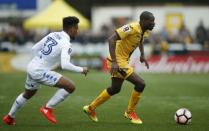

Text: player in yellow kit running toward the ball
xmin=83 ymin=11 xmax=155 ymax=124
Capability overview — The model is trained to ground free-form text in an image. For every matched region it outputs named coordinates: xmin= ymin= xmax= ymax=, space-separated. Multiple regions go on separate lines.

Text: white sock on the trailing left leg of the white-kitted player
xmin=8 ymin=93 xmax=27 ymax=118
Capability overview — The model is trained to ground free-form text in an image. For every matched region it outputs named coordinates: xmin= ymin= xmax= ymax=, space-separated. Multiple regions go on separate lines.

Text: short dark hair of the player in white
xmin=62 ymin=16 xmax=79 ymax=30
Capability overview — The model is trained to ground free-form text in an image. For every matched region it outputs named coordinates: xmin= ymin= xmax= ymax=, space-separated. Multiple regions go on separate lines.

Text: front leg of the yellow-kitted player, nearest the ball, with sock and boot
xmin=124 ymin=73 xmax=145 ymax=124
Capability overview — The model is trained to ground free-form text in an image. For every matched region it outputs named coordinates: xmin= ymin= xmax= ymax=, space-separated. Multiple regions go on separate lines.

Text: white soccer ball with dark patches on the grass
xmin=174 ymin=108 xmax=192 ymax=125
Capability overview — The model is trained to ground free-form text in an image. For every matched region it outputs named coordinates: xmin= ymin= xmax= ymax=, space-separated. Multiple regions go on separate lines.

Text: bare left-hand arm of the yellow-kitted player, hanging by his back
xmin=108 ymin=32 xmax=120 ymax=74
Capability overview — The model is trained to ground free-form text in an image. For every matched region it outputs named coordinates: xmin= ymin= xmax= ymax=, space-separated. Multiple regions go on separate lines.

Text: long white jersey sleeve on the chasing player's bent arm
xmin=61 ymin=46 xmax=83 ymax=72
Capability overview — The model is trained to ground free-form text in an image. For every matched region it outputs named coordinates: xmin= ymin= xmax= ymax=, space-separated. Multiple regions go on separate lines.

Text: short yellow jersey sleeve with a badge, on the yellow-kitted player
xmin=116 ymin=24 xmax=134 ymax=39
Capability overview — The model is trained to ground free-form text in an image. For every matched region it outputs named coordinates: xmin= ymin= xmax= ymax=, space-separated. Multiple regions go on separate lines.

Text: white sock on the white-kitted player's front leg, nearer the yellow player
xmin=46 ymin=89 xmax=69 ymax=108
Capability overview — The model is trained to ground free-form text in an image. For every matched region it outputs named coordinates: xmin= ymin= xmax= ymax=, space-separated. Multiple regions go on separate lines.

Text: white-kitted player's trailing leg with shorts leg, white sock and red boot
xmin=3 ymin=77 xmax=39 ymax=125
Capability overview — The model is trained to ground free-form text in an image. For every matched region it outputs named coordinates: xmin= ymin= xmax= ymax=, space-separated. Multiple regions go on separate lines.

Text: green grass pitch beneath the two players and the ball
xmin=0 ymin=72 xmax=209 ymax=131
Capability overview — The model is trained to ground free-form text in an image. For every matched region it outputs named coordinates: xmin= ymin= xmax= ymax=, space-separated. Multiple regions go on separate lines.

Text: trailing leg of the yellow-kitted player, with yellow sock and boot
xmin=83 ymin=77 xmax=124 ymax=122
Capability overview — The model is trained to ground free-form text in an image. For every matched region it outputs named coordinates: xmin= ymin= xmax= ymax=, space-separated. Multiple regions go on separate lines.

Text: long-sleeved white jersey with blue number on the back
xmin=27 ymin=31 xmax=83 ymax=78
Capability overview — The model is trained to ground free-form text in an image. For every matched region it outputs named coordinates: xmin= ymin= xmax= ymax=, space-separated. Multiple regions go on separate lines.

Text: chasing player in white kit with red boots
xmin=3 ymin=16 xmax=88 ymax=125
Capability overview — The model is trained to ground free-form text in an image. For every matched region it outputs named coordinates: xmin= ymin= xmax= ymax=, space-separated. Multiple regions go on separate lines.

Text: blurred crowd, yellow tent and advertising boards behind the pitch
xmin=0 ymin=0 xmax=209 ymax=73
